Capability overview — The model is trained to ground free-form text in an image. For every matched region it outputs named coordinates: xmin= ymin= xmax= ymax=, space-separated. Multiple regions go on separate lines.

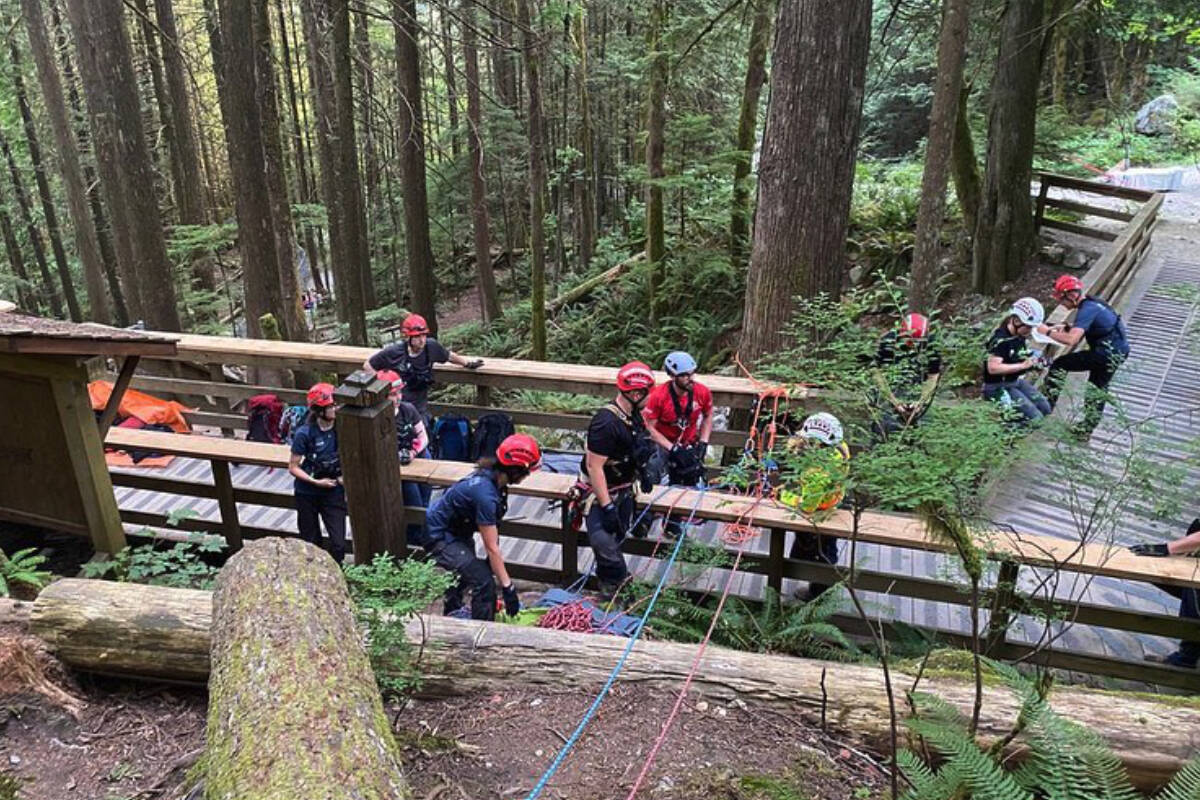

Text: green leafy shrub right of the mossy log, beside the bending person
xmin=346 ymin=554 xmax=455 ymax=697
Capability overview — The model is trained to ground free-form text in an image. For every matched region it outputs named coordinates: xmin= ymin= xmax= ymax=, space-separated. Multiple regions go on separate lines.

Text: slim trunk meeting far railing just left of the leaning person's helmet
xmin=329 ymin=0 xmax=370 ymax=345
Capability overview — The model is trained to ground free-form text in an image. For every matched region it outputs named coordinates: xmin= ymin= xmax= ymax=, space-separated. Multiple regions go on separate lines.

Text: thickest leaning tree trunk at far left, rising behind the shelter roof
xmin=67 ymin=0 xmax=180 ymax=331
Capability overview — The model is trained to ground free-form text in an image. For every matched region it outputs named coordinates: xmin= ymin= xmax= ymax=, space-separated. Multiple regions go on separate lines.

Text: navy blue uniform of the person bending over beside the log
xmin=425 ymin=469 xmax=508 ymax=620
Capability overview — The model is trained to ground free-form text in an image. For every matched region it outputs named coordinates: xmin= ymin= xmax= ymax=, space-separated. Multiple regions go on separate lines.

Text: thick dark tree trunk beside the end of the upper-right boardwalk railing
xmin=973 ymin=0 xmax=1045 ymax=294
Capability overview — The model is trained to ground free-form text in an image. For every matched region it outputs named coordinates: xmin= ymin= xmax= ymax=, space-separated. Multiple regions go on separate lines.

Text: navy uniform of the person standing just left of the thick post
xmin=292 ymin=421 xmax=346 ymax=564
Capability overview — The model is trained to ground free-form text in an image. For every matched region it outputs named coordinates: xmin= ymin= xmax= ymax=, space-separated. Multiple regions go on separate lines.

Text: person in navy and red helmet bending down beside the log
xmin=425 ymin=433 xmax=541 ymax=620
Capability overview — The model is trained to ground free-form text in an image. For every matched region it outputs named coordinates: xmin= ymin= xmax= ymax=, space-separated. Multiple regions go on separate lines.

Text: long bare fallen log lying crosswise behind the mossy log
xmin=32 ymin=581 xmax=1200 ymax=787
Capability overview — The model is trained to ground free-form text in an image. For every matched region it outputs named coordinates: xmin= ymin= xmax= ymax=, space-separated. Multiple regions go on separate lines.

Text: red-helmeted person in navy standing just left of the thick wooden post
xmin=288 ymin=384 xmax=346 ymax=564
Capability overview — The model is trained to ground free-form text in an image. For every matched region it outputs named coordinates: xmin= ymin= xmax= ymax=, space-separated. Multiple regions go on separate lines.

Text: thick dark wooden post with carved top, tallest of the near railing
xmin=334 ymin=372 xmax=408 ymax=564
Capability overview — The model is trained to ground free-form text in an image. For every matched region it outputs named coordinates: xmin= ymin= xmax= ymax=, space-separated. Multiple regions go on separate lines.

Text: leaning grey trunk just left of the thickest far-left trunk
xmin=20 ymin=0 xmax=113 ymax=325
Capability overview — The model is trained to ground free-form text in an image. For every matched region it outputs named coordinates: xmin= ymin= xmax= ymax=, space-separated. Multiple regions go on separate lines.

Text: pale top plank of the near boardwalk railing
xmin=106 ymin=428 xmax=1200 ymax=588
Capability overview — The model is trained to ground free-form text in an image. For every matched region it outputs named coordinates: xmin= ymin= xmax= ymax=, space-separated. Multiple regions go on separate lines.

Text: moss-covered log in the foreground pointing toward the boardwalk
xmin=204 ymin=537 xmax=409 ymax=800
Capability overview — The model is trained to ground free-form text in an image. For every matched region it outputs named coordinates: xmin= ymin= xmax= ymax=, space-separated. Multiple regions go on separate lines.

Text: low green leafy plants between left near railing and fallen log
xmin=83 ymin=527 xmax=224 ymax=589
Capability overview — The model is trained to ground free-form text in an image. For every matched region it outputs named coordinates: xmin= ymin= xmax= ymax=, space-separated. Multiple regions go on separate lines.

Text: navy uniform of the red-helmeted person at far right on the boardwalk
xmin=1045 ymin=297 xmax=1129 ymax=435
